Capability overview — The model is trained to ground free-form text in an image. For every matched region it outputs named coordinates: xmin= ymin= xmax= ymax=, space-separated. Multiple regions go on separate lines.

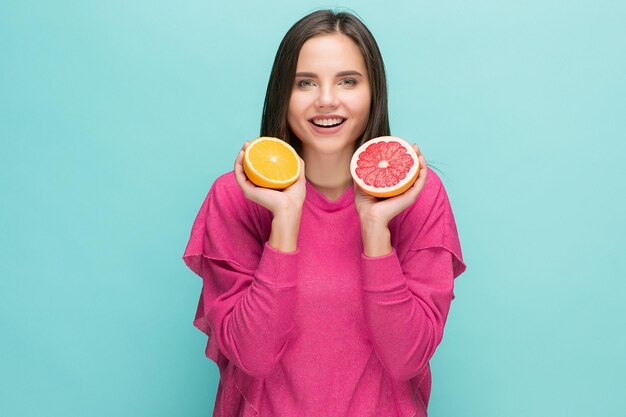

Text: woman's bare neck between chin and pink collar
xmin=302 ymin=151 xmax=352 ymax=200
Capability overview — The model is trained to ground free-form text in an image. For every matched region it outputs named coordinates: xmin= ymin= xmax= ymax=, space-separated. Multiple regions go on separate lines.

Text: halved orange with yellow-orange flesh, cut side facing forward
xmin=243 ymin=136 xmax=301 ymax=190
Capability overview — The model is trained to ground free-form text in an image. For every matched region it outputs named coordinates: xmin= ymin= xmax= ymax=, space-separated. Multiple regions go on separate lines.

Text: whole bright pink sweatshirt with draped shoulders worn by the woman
xmin=183 ymin=169 xmax=465 ymax=417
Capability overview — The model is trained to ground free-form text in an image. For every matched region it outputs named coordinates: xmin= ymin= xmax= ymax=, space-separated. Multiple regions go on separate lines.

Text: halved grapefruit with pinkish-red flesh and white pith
xmin=350 ymin=136 xmax=419 ymax=198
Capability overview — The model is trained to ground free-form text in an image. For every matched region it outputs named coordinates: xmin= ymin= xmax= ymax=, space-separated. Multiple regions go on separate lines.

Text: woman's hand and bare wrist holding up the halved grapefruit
xmin=355 ymin=144 xmax=428 ymax=257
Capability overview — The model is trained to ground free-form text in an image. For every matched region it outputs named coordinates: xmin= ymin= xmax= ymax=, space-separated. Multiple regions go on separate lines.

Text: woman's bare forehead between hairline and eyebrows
xmin=297 ymin=33 xmax=366 ymax=74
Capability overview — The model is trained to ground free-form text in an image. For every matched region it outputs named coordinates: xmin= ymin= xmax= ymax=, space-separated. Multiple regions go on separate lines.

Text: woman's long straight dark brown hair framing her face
xmin=261 ymin=10 xmax=390 ymax=152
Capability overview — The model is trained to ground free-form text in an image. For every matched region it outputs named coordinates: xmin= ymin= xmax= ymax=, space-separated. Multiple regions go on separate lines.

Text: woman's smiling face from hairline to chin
xmin=287 ymin=33 xmax=371 ymax=155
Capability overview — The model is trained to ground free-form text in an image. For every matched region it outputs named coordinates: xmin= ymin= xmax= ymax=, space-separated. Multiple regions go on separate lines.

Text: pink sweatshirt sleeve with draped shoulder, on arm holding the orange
xmin=183 ymin=173 xmax=299 ymax=377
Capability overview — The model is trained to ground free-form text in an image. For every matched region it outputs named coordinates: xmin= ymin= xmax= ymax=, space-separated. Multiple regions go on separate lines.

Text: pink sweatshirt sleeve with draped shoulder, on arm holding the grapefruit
xmin=361 ymin=171 xmax=465 ymax=380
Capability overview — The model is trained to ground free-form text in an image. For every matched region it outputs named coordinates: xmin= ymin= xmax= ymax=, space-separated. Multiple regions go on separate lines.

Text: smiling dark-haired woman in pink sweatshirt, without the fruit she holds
xmin=184 ymin=11 xmax=465 ymax=417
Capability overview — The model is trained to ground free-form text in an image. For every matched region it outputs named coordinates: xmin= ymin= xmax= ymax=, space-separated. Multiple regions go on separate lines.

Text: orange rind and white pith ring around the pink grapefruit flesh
xmin=350 ymin=136 xmax=420 ymax=198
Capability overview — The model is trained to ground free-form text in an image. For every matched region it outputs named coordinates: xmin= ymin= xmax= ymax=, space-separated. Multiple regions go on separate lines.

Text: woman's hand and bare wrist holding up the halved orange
xmin=235 ymin=142 xmax=306 ymax=252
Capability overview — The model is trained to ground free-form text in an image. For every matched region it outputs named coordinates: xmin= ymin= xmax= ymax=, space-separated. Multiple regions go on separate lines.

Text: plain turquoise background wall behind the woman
xmin=0 ymin=0 xmax=626 ymax=417
